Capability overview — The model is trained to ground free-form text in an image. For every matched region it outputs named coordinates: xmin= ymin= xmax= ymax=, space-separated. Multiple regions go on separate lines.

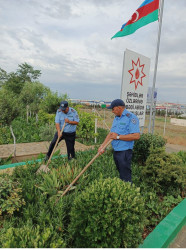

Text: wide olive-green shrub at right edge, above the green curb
xmin=141 ymin=148 xmax=185 ymax=196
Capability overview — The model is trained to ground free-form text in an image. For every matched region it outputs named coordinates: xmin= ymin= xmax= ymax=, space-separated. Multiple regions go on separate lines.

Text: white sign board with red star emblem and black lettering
xmin=121 ymin=49 xmax=150 ymax=127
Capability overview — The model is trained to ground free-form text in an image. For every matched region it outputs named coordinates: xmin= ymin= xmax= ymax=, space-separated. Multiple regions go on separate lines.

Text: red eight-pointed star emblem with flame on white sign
xmin=128 ymin=58 xmax=146 ymax=90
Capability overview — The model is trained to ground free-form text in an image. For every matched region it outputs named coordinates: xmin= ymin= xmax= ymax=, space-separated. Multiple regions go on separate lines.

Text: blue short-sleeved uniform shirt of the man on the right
xmin=111 ymin=109 xmax=140 ymax=151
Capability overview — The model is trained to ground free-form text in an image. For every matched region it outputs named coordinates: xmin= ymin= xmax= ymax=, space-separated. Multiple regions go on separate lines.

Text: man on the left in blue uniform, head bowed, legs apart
xmin=45 ymin=101 xmax=79 ymax=160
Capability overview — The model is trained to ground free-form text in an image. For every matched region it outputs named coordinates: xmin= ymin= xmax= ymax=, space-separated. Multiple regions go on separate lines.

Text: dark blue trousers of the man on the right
xmin=113 ymin=149 xmax=132 ymax=182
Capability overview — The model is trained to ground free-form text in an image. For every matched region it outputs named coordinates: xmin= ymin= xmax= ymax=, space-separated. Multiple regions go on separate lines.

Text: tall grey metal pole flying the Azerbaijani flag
xmin=148 ymin=0 xmax=164 ymax=133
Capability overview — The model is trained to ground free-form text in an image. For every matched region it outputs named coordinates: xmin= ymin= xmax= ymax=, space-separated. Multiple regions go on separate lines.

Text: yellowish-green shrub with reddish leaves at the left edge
xmin=0 ymin=176 xmax=25 ymax=215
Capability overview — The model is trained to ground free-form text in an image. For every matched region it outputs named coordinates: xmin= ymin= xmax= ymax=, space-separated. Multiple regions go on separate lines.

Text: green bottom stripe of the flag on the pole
xmin=111 ymin=10 xmax=158 ymax=39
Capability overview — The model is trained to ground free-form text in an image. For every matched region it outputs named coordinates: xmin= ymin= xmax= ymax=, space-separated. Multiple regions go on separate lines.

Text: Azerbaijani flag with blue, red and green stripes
xmin=111 ymin=0 xmax=159 ymax=39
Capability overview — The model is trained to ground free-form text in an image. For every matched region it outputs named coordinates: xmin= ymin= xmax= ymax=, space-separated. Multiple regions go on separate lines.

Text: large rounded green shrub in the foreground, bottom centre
xmin=69 ymin=178 xmax=145 ymax=248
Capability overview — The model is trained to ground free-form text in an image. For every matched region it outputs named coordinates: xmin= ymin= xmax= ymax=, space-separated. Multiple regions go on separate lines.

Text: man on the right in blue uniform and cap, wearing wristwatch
xmin=98 ymin=99 xmax=140 ymax=182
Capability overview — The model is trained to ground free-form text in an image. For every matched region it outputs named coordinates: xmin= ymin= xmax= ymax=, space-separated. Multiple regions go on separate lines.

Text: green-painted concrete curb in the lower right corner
xmin=139 ymin=199 xmax=186 ymax=248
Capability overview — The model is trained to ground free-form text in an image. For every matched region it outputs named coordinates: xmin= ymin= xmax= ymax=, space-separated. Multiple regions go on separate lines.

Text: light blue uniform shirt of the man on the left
xmin=55 ymin=107 xmax=79 ymax=133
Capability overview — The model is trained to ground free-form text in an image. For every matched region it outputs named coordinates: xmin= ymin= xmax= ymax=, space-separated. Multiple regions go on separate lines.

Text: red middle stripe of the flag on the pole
xmin=126 ymin=0 xmax=159 ymax=26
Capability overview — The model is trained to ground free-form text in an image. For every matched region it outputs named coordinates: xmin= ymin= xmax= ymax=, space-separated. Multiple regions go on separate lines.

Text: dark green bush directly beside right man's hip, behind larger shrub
xmin=133 ymin=134 xmax=166 ymax=164
